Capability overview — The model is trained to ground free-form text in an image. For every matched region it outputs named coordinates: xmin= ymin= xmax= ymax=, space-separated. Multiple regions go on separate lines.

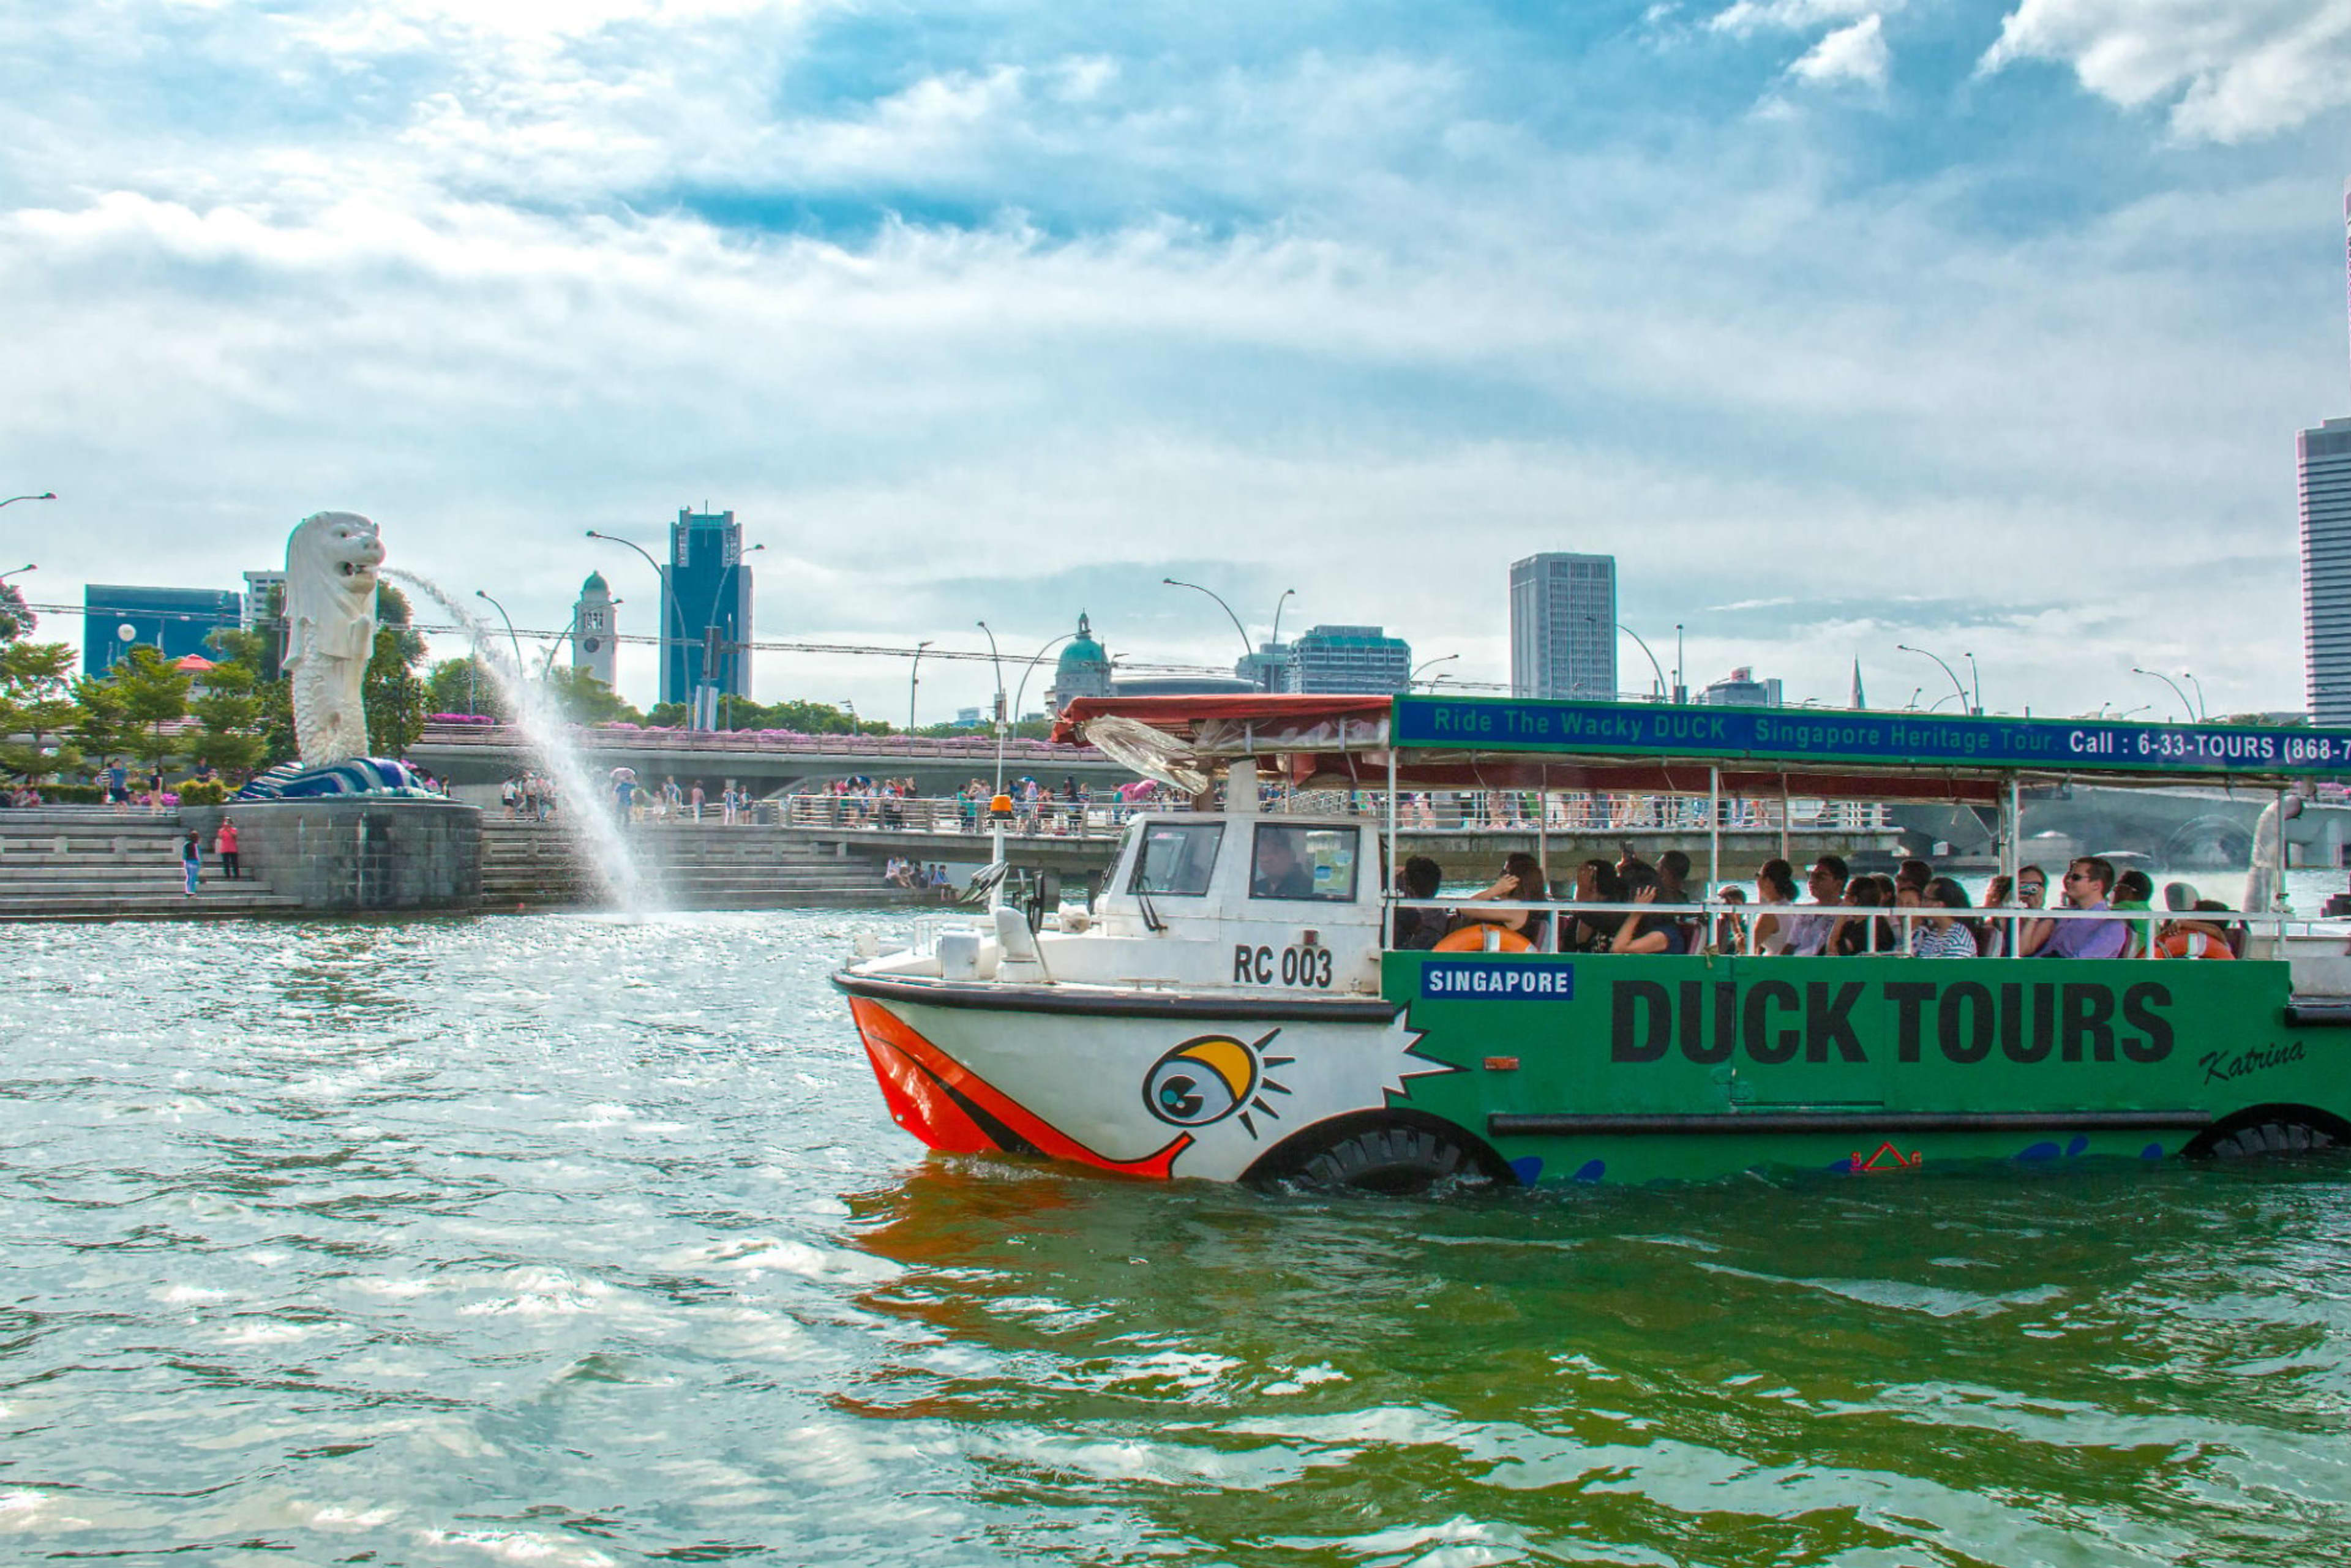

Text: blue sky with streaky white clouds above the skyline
xmin=0 ymin=0 xmax=2351 ymax=722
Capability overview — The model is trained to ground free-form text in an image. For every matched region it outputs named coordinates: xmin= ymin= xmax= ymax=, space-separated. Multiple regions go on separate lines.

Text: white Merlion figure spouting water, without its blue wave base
xmin=285 ymin=512 xmax=383 ymax=769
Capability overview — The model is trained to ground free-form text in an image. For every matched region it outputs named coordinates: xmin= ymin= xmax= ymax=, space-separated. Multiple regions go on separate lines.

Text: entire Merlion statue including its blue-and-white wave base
xmin=238 ymin=512 xmax=430 ymax=801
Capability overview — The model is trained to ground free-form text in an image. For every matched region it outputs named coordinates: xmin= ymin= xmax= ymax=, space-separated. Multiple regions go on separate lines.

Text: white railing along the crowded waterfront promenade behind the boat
xmin=773 ymin=787 xmax=1890 ymax=837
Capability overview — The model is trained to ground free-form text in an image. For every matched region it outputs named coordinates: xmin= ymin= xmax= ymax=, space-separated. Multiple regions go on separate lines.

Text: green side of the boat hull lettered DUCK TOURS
xmin=1382 ymin=952 xmax=2351 ymax=1185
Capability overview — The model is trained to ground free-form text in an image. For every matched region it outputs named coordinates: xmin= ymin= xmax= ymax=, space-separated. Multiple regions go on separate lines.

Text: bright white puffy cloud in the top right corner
xmin=1982 ymin=0 xmax=2351 ymax=143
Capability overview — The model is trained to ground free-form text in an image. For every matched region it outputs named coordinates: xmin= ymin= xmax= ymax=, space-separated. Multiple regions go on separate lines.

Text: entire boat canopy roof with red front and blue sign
xmin=1053 ymin=694 xmax=2351 ymax=801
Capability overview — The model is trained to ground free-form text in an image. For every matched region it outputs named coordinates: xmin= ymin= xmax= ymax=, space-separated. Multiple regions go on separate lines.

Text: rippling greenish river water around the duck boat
xmin=0 ymin=912 xmax=2351 ymax=1568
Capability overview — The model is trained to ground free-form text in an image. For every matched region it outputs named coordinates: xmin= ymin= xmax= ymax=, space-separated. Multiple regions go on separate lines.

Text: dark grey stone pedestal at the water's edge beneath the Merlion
xmin=179 ymin=795 xmax=482 ymax=915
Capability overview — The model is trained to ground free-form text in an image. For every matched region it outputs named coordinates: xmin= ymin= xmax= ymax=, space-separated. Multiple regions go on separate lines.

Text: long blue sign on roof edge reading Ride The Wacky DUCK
xmin=1394 ymin=696 xmax=2351 ymax=776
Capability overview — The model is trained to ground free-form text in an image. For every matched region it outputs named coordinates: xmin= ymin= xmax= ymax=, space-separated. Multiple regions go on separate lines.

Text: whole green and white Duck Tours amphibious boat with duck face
xmin=834 ymin=696 xmax=2351 ymax=1190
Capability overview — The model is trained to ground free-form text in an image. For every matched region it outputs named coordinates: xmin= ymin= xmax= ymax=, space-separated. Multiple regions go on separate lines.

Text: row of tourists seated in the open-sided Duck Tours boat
xmin=1392 ymin=846 xmax=2243 ymax=959
